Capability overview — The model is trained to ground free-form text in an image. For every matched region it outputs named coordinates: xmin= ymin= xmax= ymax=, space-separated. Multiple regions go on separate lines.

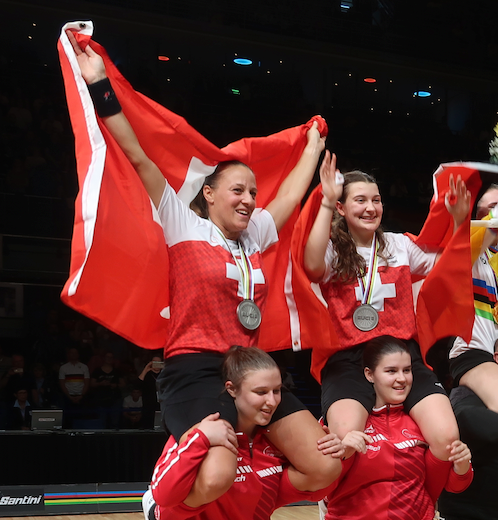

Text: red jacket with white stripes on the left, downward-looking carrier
xmin=151 ymin=429 xmax=325 ymax=520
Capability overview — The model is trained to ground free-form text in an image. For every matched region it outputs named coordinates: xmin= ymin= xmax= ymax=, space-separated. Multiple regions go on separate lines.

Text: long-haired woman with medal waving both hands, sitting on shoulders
xmin=304 ymin=153 xmax=470 ymax=468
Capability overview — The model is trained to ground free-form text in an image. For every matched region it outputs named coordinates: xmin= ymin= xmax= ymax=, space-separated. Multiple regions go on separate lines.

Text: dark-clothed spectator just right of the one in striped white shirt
xmin=90 ymin=352 xmax=124 ymax=429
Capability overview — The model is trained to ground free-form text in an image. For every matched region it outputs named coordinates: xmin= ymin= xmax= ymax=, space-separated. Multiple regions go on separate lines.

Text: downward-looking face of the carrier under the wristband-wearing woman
xmin=225 ymin=368 xmax=282 ymax=437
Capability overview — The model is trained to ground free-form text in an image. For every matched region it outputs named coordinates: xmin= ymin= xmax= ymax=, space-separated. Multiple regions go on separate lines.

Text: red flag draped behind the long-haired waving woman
xmin=286 ymin=163 xmax=486 ymax=381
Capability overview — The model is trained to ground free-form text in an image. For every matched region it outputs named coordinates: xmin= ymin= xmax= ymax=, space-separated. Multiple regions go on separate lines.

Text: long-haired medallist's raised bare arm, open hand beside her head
xmin=304 ymin=150 xmax=342 ymax=282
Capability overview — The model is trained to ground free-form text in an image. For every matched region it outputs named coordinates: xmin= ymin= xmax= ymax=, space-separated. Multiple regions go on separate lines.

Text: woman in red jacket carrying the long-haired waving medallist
xmin=323 ymin=336 xmax=473 ymax=520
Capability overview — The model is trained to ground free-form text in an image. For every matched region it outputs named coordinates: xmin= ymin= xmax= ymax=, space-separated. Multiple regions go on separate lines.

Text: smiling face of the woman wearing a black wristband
xmin=204 ymin=164 xmax=257 ymax=240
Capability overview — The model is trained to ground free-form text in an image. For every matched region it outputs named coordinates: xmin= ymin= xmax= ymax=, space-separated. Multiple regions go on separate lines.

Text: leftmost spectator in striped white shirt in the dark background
xmin=59 ymin=348 xmax=90 ymax=428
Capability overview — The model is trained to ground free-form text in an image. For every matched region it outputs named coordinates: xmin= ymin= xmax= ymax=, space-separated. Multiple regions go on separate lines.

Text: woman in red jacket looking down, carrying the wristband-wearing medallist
xmin=143 ymin=347 xmax=342 ymax=520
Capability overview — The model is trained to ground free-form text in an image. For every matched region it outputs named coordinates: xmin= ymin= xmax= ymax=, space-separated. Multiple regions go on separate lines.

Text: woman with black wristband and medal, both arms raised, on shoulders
xmin=68 ymin=32 xmax=340 ymax=507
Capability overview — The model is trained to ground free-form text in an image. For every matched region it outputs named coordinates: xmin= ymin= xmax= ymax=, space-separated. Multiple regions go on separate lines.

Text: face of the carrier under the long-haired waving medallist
xmin=365 ymin=352 xmax=413 ymax=408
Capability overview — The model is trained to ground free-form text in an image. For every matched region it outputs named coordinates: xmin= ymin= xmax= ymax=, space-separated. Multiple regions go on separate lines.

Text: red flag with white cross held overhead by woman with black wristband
xmin=58 ymin=22 xmax=327 ymax=350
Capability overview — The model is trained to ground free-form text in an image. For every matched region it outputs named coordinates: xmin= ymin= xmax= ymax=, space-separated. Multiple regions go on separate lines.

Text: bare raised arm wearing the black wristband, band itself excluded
xmin=66 ymin=30 xmax=166 ymax=208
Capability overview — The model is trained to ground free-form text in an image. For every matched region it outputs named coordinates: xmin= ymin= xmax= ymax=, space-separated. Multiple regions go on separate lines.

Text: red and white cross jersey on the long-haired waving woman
xmin=320 ymin=233 xmax=436 ymax=349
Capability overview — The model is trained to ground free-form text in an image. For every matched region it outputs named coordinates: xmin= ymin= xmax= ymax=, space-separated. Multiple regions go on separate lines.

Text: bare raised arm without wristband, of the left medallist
xmin=265 ymin=121 xmax=325 ymax=231
